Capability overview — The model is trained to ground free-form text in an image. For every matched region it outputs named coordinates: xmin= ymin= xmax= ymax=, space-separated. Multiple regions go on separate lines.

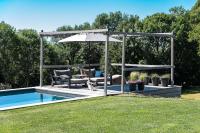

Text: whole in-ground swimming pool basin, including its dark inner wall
xmin=0 ymin=89 xmax=82 ymax=110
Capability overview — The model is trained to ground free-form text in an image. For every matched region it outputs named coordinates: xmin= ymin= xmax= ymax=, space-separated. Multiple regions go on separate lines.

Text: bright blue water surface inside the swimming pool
xmin=0 ymin=89 xmax=74 ymax=108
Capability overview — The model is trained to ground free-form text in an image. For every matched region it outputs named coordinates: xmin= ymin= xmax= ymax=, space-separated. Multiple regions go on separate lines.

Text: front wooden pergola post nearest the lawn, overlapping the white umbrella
xmin=104 ymin=34 xmax=109 ymax=96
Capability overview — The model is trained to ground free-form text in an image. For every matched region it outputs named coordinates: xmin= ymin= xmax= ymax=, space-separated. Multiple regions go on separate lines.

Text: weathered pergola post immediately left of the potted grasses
xmin=121 ymin=34 xmax=126 ymax=93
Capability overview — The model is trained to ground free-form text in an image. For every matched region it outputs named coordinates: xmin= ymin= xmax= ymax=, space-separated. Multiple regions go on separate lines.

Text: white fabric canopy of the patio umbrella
xmin=58 ymin=33 xmax=122 ymax=43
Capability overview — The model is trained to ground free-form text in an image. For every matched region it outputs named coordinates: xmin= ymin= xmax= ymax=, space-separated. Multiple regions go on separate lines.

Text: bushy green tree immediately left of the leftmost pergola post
xmin=16 ymin=29 xmax=40 ymax=87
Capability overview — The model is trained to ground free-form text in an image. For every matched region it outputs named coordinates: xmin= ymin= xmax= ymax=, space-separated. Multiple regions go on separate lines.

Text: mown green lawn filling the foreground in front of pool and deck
xmin=0 ymin=96 xmax=200 ymax=133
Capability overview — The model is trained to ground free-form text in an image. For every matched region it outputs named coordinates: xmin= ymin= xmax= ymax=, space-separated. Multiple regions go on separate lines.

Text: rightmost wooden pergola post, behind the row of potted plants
xmin=171 ymin=32 xmax=174 ymax=86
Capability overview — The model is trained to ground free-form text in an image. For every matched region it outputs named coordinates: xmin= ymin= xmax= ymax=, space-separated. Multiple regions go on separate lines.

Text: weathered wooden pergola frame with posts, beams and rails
xmin=39 ymin=29 xmax=174 ymax=96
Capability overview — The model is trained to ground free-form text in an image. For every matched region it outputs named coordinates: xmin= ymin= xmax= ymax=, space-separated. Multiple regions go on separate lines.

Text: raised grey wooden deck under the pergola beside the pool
xmin=36 ymin=84 xmax=181 ymax=98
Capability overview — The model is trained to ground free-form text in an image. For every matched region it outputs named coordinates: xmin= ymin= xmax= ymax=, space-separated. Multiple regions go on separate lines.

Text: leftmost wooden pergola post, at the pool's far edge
xmin=40 ymin=31 xmax=43 ymax=87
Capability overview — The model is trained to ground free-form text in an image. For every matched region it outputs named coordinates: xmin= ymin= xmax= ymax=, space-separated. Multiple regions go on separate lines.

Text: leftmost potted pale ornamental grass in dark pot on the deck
xmin=128 ymin=72 xmax=139 ymax=91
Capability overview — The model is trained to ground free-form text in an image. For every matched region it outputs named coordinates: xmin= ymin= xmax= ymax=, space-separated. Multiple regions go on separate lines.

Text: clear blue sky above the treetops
xmin=0 ymin=0 xmax=196 ymax=31
